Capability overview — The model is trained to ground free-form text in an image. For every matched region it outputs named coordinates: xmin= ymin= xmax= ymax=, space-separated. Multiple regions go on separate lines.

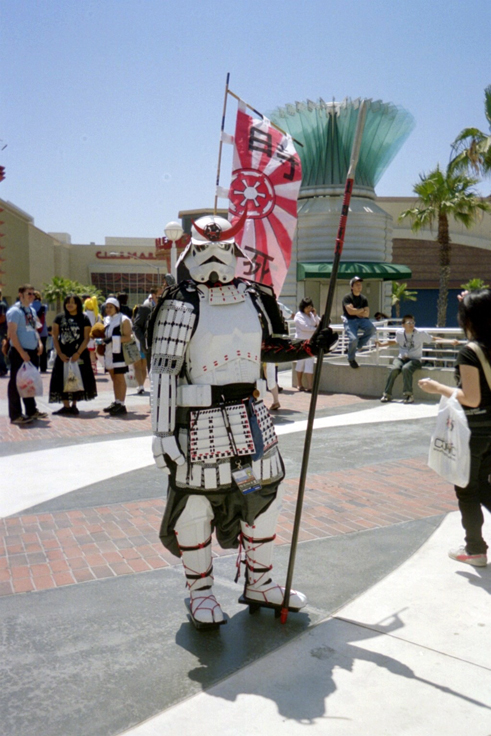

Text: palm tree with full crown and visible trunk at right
xmin=399 ymin=166 xmax=491 ymax=327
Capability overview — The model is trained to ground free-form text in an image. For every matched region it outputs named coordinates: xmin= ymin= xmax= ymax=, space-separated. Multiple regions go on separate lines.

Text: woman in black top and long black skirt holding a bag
xmin=49 ymin=295 xmax=97 ymax=416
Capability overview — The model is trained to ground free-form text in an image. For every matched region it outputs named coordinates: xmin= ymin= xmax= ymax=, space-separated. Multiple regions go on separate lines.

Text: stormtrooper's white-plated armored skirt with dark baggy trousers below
xmin=160 ymin=400 xmax=285 ymax=556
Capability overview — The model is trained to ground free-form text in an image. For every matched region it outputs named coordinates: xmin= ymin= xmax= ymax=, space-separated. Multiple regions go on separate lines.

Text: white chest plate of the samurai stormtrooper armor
xmin=186 ymin=286 xmax=262 ymax=386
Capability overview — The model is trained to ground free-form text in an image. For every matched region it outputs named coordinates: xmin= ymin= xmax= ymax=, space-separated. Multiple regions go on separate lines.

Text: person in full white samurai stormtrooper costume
xmin=148 ymin=216 xmax=337 ymax=628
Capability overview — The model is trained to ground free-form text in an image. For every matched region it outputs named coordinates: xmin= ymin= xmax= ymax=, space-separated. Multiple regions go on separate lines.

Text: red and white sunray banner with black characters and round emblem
xmin=229 ymin=104 xmax=302 ymax=295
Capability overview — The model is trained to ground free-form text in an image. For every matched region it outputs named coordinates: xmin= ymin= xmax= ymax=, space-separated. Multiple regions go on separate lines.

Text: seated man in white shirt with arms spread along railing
xmin=377 ymin=314 xmax=459 ymax=404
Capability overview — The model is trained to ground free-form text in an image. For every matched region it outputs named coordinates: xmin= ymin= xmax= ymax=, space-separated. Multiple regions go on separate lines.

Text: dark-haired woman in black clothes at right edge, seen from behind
xmin=418 ymin=289 xmax=491 ymax=567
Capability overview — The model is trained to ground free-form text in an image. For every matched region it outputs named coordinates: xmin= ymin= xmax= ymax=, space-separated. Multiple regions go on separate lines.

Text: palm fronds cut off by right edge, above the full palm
xmin=449 ymin=84 xmax=491 ymax=176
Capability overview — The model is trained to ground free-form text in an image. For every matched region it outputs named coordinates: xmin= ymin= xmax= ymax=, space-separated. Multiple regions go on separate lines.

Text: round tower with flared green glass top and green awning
xmin=269 ymin=98 xmax=415 ymax=320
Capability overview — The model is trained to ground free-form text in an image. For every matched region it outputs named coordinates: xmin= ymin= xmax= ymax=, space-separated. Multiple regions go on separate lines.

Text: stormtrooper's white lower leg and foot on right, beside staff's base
xmin=239 ymin=498 xmax=307 ymax=616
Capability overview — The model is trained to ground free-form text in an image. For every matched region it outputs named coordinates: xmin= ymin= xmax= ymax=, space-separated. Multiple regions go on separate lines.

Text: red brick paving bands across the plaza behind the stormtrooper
xmin=0 ymin=374 xmax=456 ymax=596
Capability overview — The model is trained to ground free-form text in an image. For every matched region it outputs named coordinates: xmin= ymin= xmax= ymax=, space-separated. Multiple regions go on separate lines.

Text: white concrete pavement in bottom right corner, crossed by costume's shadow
xmin=119 ymin=513 xmax=491 ymax=736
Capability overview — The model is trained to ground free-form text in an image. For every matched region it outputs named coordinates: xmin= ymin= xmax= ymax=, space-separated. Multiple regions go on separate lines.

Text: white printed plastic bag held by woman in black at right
xmin=428 ymin=391 xmax=471 ymax=488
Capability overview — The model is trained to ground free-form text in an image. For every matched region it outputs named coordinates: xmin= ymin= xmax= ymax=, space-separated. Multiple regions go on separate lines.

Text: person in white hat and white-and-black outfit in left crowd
xmin=103 ymin=296 xmax=132 ymax=416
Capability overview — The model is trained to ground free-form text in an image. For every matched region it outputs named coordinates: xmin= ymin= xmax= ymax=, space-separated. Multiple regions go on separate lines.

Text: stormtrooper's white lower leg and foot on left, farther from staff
xmin=175 ymin=496 xmax=227 ymax=629
